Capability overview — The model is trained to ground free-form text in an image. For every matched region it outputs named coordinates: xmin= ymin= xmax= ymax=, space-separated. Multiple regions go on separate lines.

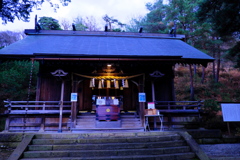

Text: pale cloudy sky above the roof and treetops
xmin=0 ymin=0 xmax=161 ymax=31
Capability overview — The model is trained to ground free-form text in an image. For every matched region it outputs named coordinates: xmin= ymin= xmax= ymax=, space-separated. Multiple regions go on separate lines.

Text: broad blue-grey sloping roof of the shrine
xmin=0 ymin=30 xmax=213 ymax=61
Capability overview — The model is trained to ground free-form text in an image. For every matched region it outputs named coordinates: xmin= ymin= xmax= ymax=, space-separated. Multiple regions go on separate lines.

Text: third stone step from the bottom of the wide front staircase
xmin=28 ymin=140 xmax=186 ymax=151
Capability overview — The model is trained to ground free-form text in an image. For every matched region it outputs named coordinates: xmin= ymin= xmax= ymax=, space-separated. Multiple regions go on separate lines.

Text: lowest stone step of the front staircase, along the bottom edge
xmin=21 ymin=152 xmax=196 ymax=160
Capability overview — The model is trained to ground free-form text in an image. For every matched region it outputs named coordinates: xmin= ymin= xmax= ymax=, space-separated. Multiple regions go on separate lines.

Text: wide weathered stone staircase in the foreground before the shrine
xmin=13 ymin=132 xmax=201 ymax=160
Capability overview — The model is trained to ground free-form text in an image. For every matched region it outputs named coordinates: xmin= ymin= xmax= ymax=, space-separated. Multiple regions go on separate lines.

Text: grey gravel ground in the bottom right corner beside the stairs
xmin=200 ymin=143 xmax=240 ymax=160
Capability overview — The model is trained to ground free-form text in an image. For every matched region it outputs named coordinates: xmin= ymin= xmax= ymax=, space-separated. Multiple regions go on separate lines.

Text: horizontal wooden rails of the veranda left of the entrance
xmin=4 ymin=101 xmax=71 ymax=114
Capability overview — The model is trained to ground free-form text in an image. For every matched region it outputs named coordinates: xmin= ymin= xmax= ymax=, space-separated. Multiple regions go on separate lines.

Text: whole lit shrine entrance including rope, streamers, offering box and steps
xmin=76 ymin=73 xmax=143 ymax=128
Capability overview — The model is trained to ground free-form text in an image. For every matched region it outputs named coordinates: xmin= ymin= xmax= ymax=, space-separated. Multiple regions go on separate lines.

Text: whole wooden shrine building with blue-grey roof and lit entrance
xmin=0 ymin=29 xmax=214 ymax=132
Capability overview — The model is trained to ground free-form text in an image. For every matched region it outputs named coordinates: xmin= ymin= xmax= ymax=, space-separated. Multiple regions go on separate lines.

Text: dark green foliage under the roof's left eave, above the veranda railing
xmin=0 ymin=61 xmax=39 ymax=112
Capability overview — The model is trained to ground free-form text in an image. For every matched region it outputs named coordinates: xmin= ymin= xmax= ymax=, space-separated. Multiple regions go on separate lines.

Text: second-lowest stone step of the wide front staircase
xmin=23 ymin=146 xmax=190 ymax=158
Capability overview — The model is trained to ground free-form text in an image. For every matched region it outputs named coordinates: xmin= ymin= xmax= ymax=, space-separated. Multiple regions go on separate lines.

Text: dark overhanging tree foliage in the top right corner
xmin=197 ymin=0 xmax=240 ymax=68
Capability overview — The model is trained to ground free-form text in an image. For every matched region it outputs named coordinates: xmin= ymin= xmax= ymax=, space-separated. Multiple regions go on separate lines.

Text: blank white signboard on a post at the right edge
xmin=221 ymin=103 xmax=240 ymax=122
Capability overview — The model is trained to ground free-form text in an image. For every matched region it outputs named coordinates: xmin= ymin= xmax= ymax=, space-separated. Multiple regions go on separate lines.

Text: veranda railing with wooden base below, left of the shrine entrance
xmin=4 ymin=101 xmax=71 ymax=132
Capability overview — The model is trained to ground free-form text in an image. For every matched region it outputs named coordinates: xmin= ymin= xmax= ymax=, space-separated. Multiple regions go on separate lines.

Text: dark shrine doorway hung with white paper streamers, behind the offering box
xmin=77 ymin=76 xmax=139 ymax=112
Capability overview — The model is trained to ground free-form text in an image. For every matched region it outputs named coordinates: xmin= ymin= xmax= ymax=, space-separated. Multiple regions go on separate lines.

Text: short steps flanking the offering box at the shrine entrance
xmin=72 ymin=113 xmax=144 ymax=132
